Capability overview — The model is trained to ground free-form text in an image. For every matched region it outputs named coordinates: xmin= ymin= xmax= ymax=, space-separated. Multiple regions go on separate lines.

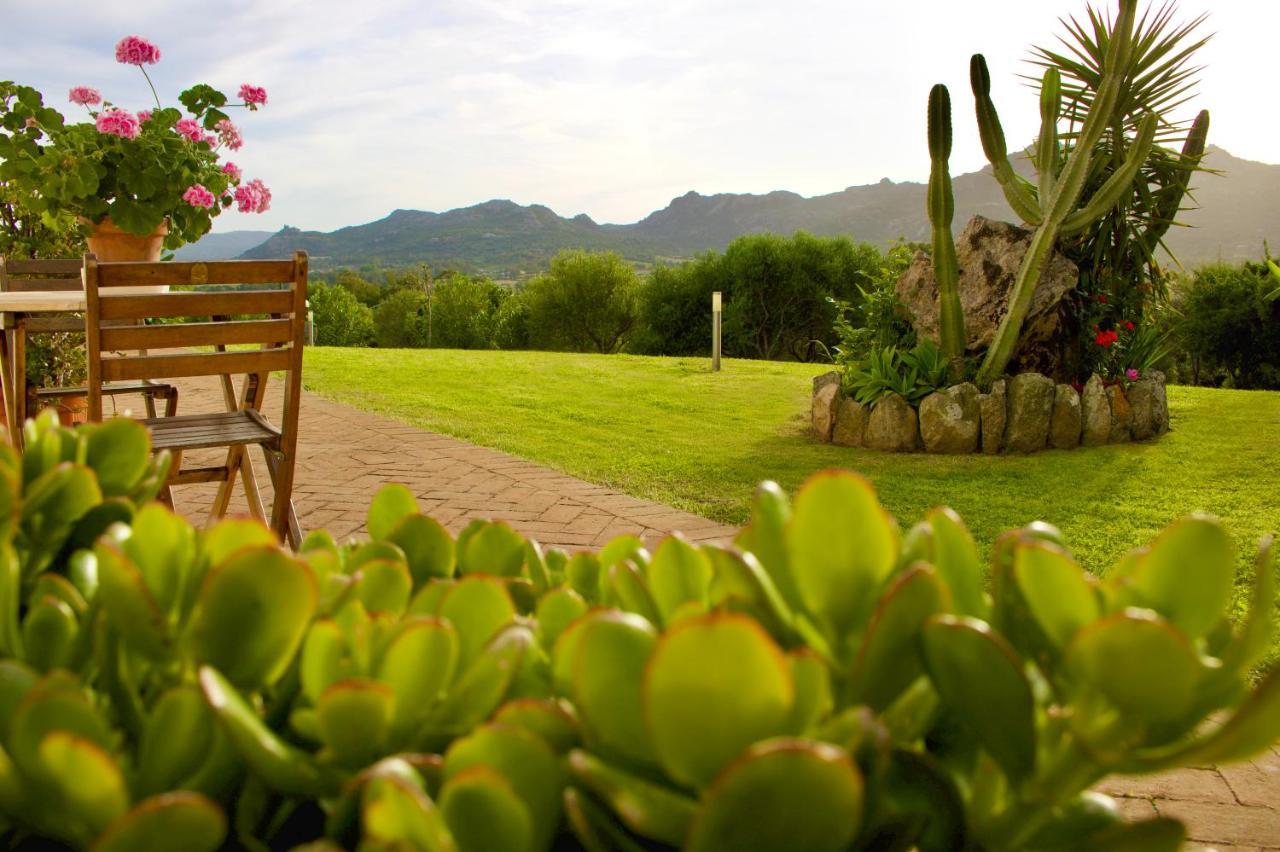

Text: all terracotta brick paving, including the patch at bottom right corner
xmin=117 ymin=381 xmax=1280 ymax=852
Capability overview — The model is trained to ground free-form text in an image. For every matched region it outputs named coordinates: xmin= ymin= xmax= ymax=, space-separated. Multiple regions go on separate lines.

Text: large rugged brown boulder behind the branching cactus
xmin=897 ymin=216 xmax=1079 ymax=375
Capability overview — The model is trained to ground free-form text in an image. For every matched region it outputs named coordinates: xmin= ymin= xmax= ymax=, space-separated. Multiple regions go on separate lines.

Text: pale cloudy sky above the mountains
xmin=0 ymin=0 xmax=1280 ymax=232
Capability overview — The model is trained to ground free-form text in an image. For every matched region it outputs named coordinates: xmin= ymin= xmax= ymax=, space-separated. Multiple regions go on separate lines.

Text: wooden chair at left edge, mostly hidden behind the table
xmin=0 ymin=257 xmax=178 ymax=423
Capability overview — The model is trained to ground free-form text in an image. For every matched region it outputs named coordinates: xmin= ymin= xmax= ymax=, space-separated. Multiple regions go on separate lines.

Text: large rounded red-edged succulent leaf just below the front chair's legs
xmin=191 ymin=548 xmax=317 ymax=688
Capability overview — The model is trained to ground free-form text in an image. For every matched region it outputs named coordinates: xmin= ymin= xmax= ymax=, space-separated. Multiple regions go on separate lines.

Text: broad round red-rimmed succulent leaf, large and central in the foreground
xmin=644 ymin=613 xmax=795 ymax=788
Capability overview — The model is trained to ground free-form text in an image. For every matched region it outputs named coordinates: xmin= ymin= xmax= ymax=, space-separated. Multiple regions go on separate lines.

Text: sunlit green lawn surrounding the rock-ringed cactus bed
xmin=303 ymin=347 xmax=1280 ymax=656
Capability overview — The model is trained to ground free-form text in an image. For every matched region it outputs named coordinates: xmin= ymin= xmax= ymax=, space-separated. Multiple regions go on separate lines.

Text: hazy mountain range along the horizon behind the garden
xmin=178 ymin=148 xmax=1280 ymax=278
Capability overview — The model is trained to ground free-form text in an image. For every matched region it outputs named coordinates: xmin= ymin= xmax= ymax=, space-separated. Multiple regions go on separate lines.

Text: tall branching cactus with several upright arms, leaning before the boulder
xmin=970 ymin=0 xmax=1158 ymax=385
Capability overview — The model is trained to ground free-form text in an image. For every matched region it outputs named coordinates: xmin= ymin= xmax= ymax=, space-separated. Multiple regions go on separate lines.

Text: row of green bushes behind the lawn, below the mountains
xmin=311 ymin=232 xmax=913 ymax=361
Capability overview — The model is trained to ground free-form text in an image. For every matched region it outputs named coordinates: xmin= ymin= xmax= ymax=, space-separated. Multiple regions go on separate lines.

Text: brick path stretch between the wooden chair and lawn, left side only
xmin=158 ymin=380 xmax=736 ymax=550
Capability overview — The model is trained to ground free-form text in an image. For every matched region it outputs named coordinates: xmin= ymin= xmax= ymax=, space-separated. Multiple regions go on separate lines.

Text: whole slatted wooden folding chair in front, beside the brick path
xmin=84 ymin=252 xmax=307 ymax=546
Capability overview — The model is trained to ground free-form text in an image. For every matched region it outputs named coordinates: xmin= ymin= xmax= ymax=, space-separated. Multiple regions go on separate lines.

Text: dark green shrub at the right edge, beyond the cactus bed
xmin=1176 ymin=264 xmax=1280 ymax=389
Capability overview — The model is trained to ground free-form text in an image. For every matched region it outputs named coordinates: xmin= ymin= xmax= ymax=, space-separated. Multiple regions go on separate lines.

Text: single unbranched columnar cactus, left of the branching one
xmin=928 ymin=83 xmax=968 ymax=381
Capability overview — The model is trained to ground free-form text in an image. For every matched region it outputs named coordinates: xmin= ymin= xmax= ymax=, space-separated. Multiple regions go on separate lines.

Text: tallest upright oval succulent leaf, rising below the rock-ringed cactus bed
xmin=787 ymin=471 xmax=900 ymax=636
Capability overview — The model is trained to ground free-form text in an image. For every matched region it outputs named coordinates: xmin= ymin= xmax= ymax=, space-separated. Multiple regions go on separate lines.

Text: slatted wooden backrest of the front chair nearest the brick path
xmin=83 ymin=252 xmax=307 ymax=424
